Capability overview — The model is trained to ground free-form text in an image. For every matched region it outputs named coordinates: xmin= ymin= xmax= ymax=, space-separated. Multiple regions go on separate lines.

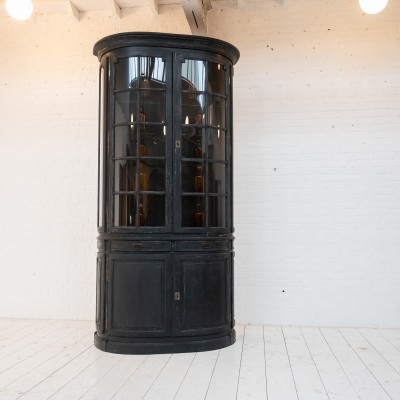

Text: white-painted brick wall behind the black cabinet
xmin=0 ymin=0 xmax=400 ymax=327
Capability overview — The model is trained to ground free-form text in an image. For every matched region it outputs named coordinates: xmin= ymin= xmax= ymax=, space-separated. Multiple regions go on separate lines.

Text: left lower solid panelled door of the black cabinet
xmin=107 ymin=253 xmax=172 ymax=337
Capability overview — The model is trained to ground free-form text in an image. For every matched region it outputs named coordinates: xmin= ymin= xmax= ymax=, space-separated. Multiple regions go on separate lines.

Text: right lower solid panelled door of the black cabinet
xmin=174 ymin=253 xmax=232 ymax=336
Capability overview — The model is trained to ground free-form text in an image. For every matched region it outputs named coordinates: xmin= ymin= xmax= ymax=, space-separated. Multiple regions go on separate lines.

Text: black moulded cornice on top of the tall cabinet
xmin=93 ymin=32 xmax=240 ymax=64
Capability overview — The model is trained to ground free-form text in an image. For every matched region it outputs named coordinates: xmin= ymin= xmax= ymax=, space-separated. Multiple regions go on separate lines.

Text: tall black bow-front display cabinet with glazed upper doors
xmin=93 ymin=32 xmax=239 ymax=354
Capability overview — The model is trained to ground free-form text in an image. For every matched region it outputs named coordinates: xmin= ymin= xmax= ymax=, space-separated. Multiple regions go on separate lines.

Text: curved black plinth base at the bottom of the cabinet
xmin=94 ymin=329 xmax=236 ymax=354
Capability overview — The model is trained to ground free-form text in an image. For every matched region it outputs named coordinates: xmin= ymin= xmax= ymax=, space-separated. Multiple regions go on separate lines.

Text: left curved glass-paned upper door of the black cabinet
xmin=113 ymin=56 xmax=172 ymax=230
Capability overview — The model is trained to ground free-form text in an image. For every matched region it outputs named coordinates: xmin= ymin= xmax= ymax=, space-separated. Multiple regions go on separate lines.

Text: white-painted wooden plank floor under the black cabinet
xmin=0 ymin=319 xmax=400 ymax=400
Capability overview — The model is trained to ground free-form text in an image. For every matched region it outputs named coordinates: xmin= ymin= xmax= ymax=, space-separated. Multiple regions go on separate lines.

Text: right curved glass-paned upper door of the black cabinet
xmin=178 ymin=59 xmax=229 ymax=230
